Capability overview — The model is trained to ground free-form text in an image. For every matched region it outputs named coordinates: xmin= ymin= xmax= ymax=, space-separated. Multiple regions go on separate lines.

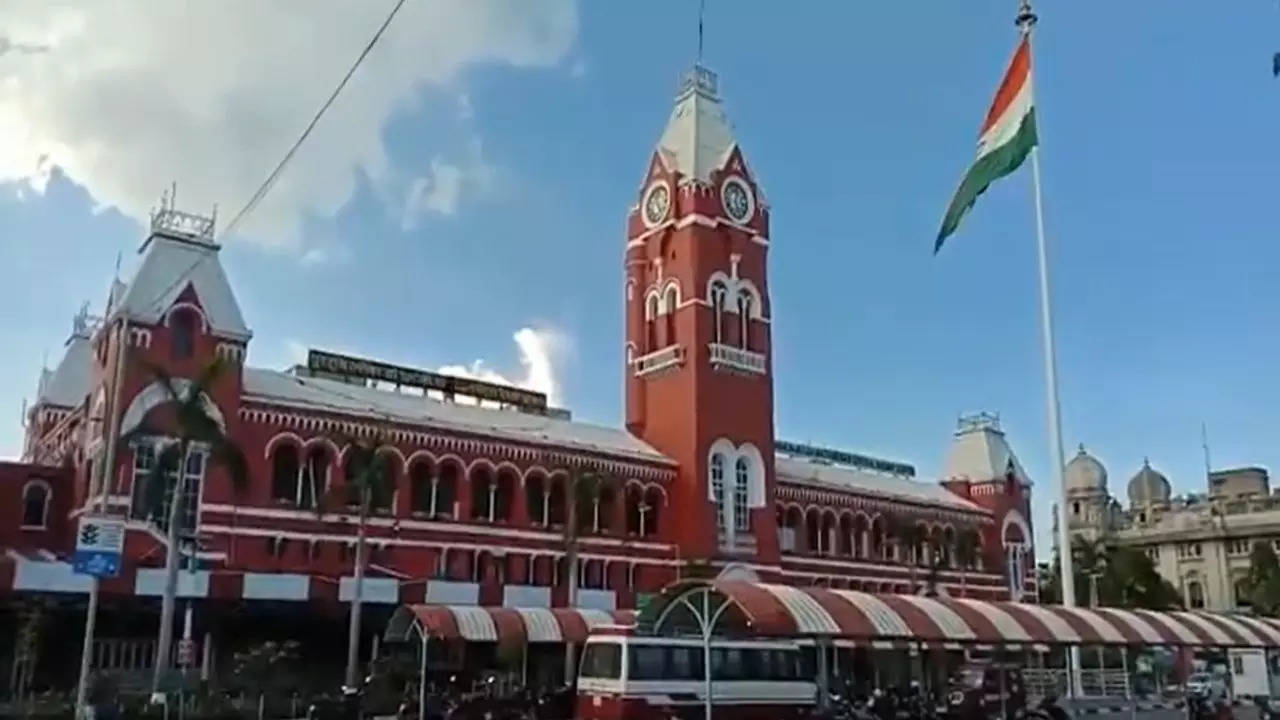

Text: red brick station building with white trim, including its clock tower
xmin=0 ymin=68 xmax=1034 ymax=681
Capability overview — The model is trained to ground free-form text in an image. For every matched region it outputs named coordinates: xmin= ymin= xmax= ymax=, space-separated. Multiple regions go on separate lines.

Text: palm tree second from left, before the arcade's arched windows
xmin=315 ymin=434 xmax=396 ymax=689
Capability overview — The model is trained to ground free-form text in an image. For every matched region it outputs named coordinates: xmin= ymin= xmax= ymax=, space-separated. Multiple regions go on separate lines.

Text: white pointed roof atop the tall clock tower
xmin=658 ymin=65 xmax=737 ymax=182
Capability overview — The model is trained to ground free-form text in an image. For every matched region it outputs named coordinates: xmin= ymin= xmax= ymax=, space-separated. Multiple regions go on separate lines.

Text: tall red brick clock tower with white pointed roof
xmin=625 ymin=65 xmax=778 ymax=566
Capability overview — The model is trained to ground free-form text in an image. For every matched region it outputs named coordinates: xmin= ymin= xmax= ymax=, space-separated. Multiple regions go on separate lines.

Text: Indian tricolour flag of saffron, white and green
xmin=933 ymin=37 xmax=1037 ymax=254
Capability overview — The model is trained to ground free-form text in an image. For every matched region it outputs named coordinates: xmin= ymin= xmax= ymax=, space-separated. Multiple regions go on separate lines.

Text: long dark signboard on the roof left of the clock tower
xmin=307 ymin=350 xmax=548 ymax=414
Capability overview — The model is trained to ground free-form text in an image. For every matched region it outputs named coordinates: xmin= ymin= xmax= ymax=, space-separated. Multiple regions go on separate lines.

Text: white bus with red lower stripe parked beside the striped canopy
xmin=576 ymin=628 xmax=818 ymax=720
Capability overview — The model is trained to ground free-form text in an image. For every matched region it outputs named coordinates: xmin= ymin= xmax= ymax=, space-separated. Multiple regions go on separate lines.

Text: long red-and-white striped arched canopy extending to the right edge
xmin=637 ymin=580 xmax=1280 ymax=648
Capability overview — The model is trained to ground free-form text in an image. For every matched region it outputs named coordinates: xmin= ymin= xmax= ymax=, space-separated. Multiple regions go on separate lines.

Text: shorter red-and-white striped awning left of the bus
xmin=385 ymin=605 xmax=636 ymax=644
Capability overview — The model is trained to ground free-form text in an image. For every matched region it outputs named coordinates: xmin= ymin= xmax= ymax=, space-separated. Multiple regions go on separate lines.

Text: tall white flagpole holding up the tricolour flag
xmin=1016 ymin=0 xmax=1082 ymax=697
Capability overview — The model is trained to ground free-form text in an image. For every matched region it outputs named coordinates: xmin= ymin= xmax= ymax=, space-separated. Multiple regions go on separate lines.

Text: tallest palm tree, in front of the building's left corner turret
xmin=120 ymin=360 xmax=248 ymax=701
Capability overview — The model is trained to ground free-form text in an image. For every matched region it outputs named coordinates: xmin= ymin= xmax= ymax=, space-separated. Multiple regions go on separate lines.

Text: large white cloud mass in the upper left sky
xmin=0 ymin=0 xmax=577 ymax=245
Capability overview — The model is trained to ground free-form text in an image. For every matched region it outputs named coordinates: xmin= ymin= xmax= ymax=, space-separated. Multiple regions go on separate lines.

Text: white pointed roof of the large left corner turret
xmin=113 ymin=232 xmax=252 ymax=341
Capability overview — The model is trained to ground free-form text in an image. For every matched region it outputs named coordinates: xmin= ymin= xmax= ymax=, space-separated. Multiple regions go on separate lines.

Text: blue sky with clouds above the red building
xmin=0 ymin=0 xmax=1280 ymax=559
